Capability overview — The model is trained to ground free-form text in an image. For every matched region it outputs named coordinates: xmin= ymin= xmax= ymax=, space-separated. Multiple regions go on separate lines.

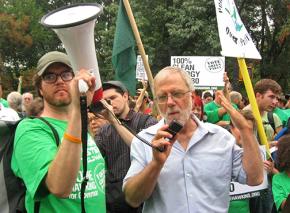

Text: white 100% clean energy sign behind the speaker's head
xmin=171 ymin=56 xmax=225 ymax=90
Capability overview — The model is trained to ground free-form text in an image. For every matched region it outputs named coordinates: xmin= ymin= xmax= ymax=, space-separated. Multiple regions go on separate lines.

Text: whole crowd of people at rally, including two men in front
xmin=0 ymin=51 xmax=290 ymax=213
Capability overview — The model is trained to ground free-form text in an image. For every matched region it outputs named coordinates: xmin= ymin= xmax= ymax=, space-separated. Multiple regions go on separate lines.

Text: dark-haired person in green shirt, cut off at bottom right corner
xmin=272 ymin=134 xmax=290 ymax=212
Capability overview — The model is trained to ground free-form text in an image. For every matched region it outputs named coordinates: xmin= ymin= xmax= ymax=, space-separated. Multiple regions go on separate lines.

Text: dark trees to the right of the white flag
xmin=239 ymin=0 xmax=290 ymax=90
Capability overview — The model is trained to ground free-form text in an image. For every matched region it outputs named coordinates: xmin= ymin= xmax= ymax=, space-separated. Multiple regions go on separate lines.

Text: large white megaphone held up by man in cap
xmin=41 ymin=3 xmax=103 ymax=104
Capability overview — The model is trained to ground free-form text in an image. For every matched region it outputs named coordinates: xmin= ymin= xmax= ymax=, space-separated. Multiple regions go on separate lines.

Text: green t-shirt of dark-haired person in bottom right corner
xmin=272 ymin=172 xmax=290 ymax=210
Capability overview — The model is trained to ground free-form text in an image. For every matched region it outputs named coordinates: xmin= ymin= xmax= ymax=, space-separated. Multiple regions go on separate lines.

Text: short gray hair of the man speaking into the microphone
xmin=153 ymin=66 xmax=194 ymax=93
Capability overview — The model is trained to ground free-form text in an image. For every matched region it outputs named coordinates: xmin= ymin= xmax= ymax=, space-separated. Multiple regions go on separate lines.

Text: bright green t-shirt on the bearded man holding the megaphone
xmin=11 ymin=118 xmax=106 ymax=213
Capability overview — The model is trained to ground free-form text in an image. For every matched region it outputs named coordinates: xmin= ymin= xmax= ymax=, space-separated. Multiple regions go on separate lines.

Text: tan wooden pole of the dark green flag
xmin=123 ymin=0 xmax=154 ymax=94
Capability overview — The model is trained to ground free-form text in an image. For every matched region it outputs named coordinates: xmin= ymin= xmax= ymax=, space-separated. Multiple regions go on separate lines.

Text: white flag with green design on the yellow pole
xmin=214 ymin=0 xmax=261 ymax=59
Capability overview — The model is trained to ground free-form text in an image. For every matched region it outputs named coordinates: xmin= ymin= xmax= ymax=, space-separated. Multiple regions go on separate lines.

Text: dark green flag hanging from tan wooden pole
xmin=112 ymin=0 xmax=136 ymax=95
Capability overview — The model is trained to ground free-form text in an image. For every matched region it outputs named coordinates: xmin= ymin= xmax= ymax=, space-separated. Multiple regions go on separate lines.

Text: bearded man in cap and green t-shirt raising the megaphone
xmin=11 ymin=51 xmax=106 ymax=213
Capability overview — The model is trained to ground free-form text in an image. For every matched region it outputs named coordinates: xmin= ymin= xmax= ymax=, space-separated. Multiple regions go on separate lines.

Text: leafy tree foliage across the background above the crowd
xmin=0 ymin=0 xmax=290 ymax=94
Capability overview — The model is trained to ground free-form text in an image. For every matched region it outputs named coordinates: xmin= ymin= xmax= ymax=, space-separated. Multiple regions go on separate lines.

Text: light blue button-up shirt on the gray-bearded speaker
xmin=123 ymin=117 xmax=246 ymax=213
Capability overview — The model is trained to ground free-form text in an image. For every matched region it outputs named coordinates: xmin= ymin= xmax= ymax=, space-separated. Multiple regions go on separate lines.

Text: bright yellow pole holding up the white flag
xmin=238 ymin=58 xmax=271 ymax=158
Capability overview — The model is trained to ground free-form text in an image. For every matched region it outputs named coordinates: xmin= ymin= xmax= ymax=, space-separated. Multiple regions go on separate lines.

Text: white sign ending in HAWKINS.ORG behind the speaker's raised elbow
xmin=230 ymin=146 xmax=268 ymax=200
